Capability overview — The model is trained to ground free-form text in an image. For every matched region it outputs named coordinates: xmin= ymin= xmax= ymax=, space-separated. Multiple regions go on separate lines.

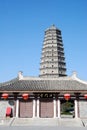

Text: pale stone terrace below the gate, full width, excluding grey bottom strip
xmin=0 ymin=118 xmax=87 ymax=128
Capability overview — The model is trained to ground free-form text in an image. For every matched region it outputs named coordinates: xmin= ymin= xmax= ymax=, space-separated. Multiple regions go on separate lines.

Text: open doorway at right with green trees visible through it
xmin=60 ymin=100 xmax=75 ymax=118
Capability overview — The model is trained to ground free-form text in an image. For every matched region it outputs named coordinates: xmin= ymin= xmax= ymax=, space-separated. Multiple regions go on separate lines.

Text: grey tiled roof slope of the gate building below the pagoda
xmin=0 ymin=77 xmax=87 ymax=91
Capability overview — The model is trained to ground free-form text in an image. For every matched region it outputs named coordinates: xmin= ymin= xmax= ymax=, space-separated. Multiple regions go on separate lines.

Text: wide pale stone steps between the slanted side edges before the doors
xmin=12 ymin=118 xmax=83 ymax=127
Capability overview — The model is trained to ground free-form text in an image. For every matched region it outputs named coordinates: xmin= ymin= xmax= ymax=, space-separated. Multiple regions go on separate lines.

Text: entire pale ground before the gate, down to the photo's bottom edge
xmin=0 ymin=118 xmax=87 ymax=130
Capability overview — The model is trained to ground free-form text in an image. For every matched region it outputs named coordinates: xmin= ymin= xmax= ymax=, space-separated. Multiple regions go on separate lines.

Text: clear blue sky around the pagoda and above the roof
xmin=0 ymin=0 xmax=87 ymax=82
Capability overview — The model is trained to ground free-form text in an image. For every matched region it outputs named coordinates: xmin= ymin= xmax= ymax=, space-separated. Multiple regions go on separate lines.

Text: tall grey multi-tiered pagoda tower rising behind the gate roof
xmin=40 ymin=25 xmax=66 ymax=78
